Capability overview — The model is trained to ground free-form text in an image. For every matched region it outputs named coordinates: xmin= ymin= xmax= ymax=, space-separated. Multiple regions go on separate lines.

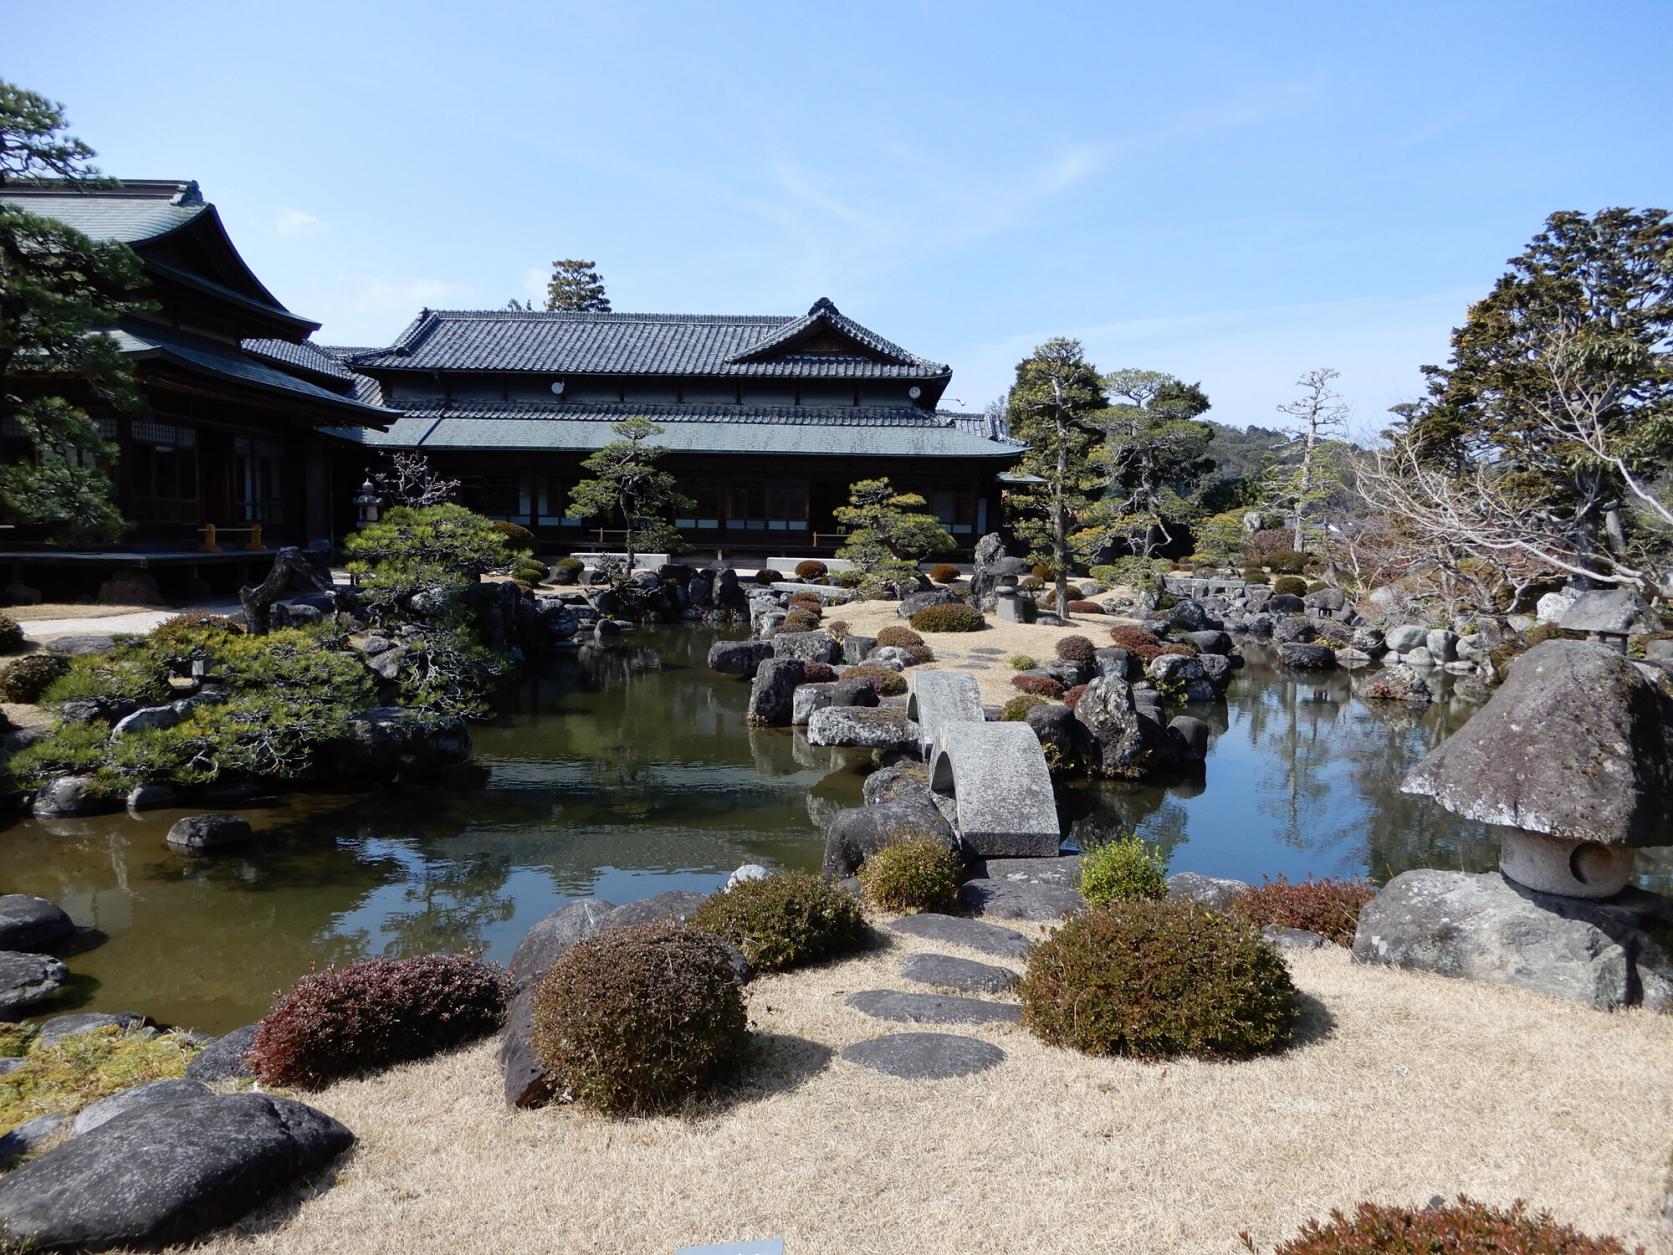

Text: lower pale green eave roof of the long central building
xmin=317 ymin=403 xmax=1021 ymax=458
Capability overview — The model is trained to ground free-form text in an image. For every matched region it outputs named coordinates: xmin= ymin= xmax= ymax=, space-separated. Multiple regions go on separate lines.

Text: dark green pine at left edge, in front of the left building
xmin=0 ymin=82 xmax=144 ymax=542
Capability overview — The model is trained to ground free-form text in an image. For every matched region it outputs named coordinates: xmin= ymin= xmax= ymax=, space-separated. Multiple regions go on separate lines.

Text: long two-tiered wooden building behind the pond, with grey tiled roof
xmin=319 ymin=300 xmax=1022 ymax=556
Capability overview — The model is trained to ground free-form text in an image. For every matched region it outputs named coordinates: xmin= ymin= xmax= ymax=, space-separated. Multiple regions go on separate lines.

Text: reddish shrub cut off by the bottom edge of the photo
xmin=1273 ymin=1195 xmax=1643 ymax=1255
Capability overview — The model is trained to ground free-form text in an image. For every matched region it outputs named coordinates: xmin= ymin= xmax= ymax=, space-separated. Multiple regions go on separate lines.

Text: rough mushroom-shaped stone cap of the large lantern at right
xmin=1400 ymin=641 xmax=1673 ymax=845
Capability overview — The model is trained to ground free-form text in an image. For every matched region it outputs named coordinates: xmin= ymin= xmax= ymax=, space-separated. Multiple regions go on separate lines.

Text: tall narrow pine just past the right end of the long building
xmin=1005 ymin=338 xmax=1108 ymax=606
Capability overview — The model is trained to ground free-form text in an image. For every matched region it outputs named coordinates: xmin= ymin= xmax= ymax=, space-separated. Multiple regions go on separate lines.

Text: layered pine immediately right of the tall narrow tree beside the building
xmin=1074 ymin=370 xmax=1215 ymax=557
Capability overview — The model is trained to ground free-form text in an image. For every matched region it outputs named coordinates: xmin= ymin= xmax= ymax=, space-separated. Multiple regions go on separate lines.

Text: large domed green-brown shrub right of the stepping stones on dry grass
xmin=1019 ymin=899 xmax=1298 ymax=1059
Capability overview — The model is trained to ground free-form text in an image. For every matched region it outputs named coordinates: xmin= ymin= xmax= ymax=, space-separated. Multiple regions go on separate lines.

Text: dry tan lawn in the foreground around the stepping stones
xmin=189 ymin=937 xmax=1673 ymax=1255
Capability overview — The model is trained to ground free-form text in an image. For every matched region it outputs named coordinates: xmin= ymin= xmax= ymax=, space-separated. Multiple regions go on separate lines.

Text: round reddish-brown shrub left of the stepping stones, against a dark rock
xmin=534 ymin=920 xmax=750 ymax=1114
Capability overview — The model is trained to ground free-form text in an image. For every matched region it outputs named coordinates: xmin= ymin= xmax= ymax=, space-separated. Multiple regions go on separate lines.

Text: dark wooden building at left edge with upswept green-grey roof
xmin=0 ymin=179 xmax=391 ymax=595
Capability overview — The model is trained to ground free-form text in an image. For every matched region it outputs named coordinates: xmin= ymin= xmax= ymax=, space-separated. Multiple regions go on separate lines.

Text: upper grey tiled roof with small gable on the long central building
xmin=353 ymin=301 xmax=952 ymax=380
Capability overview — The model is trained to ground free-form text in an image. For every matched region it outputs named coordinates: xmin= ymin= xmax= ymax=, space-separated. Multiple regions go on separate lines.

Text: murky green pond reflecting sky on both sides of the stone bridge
xmin=0 ymin=626 xmax=1673 ymax=1032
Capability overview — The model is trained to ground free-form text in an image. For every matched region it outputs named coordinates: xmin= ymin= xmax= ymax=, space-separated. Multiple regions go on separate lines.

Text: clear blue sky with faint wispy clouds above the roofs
xmin=13 ymin=0 xmax=1673 ymax=428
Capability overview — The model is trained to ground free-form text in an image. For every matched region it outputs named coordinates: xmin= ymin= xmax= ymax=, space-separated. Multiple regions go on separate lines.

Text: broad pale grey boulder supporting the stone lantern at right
xmin=1353 ymin=870 xmax=1673 ymax=1012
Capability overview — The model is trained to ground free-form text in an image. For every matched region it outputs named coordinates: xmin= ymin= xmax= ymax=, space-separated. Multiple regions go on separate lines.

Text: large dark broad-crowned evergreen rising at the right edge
xmin=1402 ymin=209 xmax=1673 ymax=565
